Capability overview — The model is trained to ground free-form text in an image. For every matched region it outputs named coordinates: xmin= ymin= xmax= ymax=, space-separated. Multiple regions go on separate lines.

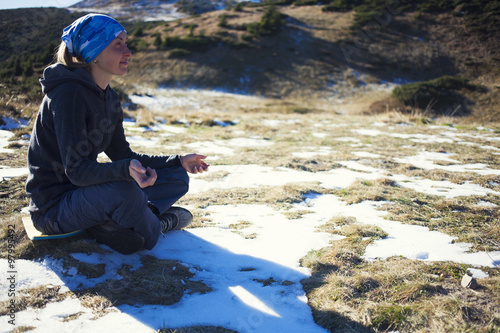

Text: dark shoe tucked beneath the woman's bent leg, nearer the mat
xmin=87 ymin=222 xmax=144 ymax=254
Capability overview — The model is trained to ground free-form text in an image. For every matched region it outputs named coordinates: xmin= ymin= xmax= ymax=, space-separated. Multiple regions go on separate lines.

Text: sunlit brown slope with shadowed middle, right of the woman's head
xmin=119 ymin=6 xmax=500 ymax=122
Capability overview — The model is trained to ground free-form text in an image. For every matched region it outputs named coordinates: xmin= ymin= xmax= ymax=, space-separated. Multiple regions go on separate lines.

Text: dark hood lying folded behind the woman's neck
xmin=40 ymin=63 xmax=102 ymax=94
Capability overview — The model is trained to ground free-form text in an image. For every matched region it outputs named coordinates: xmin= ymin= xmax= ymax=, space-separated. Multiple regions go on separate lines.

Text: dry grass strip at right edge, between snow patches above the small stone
xmin=336 ymin=178 xmax=500 ymax=251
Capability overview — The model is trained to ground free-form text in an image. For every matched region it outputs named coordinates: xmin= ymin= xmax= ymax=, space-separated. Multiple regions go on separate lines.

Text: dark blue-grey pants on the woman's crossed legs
xmin=34 ymin=166 xmax=189 ymax=249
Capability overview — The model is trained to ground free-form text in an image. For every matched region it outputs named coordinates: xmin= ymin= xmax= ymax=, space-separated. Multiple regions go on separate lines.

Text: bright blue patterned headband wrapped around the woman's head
xmin=61 ymin=14 xmax=125 ymax=63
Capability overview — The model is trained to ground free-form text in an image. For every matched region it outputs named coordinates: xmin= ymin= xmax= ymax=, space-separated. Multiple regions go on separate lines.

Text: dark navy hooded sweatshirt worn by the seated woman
xmin=26 ymin=64 xmax=180 ymax=219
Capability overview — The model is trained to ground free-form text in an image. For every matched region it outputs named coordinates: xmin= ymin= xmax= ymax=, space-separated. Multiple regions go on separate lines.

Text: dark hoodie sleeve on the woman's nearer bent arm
xmin=51 ymin=84 xmax=132 ymax=186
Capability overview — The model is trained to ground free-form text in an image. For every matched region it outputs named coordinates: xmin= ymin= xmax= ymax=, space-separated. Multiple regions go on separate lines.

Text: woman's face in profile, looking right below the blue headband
xmin=92 ymin=31 xmax=132 ymax=76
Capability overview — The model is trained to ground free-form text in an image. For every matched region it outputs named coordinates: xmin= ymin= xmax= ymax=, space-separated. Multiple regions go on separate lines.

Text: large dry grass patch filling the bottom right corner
xmin=301 ymin=218 xmax=500 ymax=332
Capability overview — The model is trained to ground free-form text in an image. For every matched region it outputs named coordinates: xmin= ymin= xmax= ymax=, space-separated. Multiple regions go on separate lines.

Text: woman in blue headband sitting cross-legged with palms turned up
xmin=26 ymin=14 xmax=208 ymax=254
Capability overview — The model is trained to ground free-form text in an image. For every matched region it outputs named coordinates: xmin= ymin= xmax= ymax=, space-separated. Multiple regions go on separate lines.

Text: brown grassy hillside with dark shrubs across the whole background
xmin=0 ymin=0 xmax=500 ymax=123
